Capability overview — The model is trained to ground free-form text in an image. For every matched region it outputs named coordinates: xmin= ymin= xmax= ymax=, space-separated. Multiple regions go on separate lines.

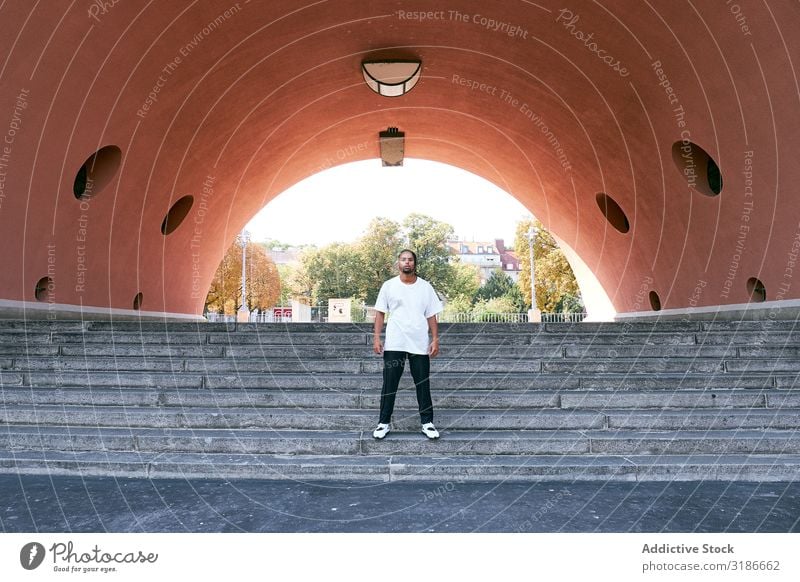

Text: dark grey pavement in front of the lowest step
xmin=0 ymin=475 xmax=800 ymax=533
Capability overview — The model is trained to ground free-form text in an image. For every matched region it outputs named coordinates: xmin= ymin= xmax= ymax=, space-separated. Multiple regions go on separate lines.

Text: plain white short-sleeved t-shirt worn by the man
xmin=375 ymin=276 xmax=442 ymax=354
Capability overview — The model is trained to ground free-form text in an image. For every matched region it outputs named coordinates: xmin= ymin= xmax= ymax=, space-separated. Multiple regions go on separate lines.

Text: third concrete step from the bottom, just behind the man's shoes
xmin=6 ymin=405 xmax=800 ymax=431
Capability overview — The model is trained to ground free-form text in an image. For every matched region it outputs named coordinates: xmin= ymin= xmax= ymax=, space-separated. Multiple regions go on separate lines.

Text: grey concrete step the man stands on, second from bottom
xmin=6 ymin=425 xmax=800 ymax=456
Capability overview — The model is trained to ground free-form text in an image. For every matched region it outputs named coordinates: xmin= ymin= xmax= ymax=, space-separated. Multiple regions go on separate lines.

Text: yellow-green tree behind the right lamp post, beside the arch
xmin=514 ymin=220 xmax=582 ymax=313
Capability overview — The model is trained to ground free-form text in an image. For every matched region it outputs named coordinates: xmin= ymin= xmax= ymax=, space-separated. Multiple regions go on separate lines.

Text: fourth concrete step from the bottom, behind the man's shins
xmin=7 ymin=386 xmax=800 ymax=410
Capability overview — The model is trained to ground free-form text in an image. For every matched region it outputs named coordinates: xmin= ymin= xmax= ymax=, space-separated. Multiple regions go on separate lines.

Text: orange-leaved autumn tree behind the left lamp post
xmin=205 ymin=239 xmax=281 ymax=314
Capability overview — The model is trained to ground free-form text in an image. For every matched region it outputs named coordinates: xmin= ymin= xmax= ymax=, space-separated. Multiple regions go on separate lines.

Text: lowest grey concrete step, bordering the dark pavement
xmin=0 ymin=450 xmax=800 ymax=484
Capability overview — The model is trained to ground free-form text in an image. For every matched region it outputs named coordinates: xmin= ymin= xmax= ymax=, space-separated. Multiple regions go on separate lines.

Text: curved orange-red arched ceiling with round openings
xmin=0 ymin=0 xmax=800 ymax=314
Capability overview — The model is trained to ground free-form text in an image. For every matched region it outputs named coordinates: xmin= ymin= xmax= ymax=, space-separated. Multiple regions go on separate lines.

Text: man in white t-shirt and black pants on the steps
xmin=372 ymin=249 xmax=442 ymax=439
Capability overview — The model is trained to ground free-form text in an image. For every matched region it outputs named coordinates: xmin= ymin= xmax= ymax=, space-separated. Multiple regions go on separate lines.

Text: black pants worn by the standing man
xmin=379 ymin=351 xmax=433 ymax=424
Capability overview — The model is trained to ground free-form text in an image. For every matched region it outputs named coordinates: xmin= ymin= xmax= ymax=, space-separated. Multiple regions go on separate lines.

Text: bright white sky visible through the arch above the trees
xmin=246 ymin=158 xmax=530 ymax=246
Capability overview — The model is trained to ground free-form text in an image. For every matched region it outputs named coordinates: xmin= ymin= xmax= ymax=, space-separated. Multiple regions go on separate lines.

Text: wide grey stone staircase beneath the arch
xmin=0 ymin=321 xmax=800 ymax=481
